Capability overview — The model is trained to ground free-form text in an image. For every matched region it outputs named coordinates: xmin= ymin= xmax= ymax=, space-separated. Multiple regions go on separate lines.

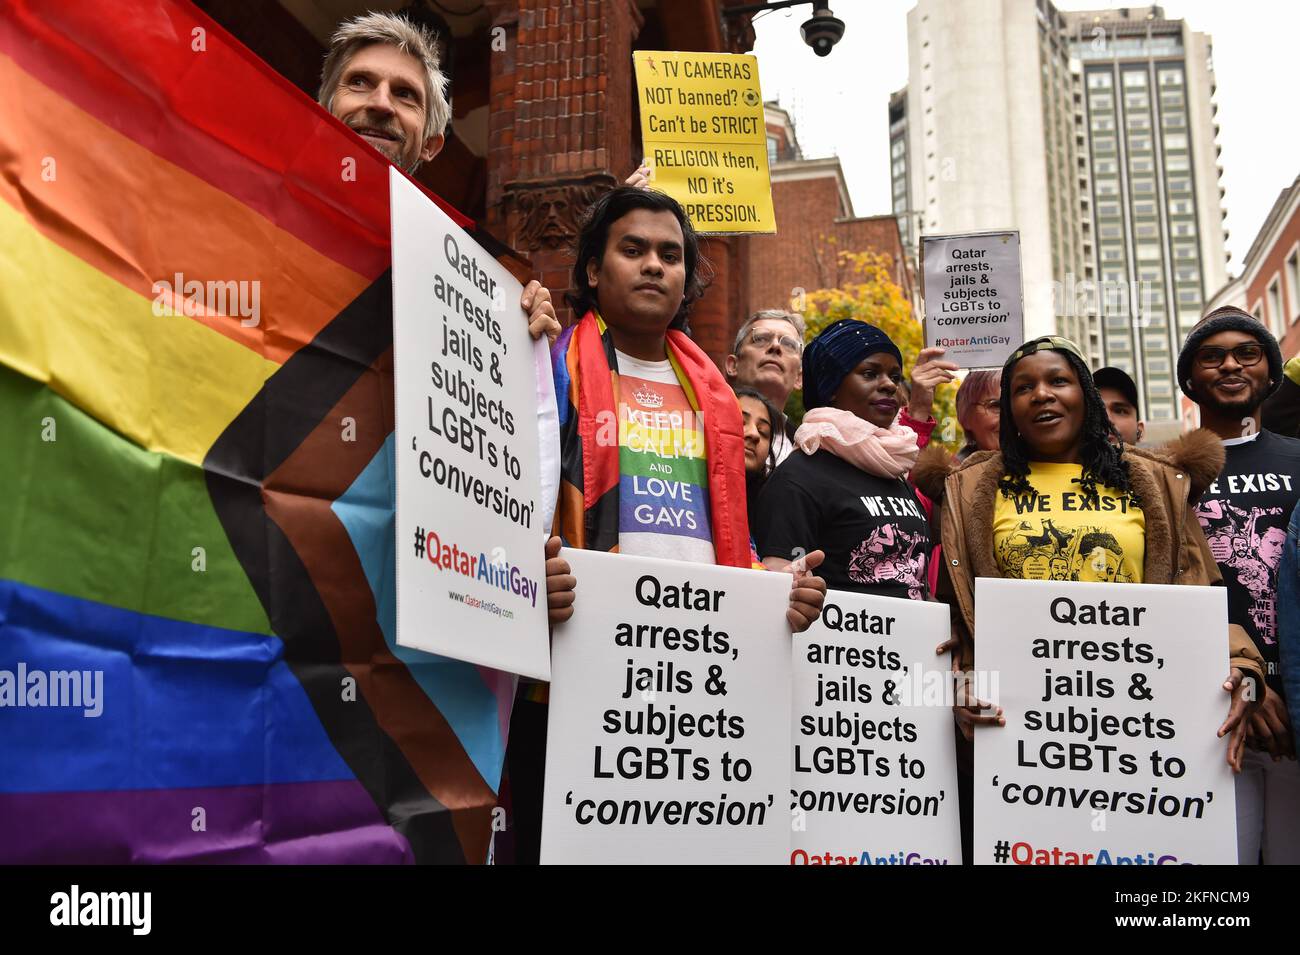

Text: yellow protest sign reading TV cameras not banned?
xmin=632 ymin=49 xmax=776 ymax=234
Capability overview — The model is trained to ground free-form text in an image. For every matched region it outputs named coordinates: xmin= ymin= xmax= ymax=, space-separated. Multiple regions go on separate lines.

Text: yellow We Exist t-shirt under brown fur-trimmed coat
xmin=993 ymin=463 xmax=1147 ymax=583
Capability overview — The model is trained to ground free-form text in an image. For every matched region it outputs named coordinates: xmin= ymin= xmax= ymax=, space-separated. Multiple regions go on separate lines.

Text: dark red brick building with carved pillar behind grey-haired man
xmin=196 ymin=0 xmax=764 ymax=361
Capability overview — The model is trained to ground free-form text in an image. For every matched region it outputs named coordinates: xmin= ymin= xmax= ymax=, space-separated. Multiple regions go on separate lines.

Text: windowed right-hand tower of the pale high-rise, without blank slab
xmin=1065 ymin=6 xmax=1227 ymax=421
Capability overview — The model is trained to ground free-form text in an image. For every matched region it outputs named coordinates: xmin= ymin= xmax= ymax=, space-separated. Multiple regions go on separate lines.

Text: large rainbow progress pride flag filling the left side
xmin=0 ymin=0 xmax=514 ymax=863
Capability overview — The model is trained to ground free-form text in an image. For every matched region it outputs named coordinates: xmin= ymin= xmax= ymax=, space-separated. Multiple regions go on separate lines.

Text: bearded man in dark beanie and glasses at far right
xmin=1178 ymin=305 xmax=1300 ymax=864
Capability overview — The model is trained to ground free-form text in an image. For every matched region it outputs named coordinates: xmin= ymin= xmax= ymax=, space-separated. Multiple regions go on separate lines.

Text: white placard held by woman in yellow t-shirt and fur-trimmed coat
xmin=972 ymin=577 xmax=1236 ymax=865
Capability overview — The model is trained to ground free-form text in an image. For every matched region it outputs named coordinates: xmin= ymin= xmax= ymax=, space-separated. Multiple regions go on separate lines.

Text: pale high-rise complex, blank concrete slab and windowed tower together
xmin=889 ymin=0 xmax=1227 ymax=438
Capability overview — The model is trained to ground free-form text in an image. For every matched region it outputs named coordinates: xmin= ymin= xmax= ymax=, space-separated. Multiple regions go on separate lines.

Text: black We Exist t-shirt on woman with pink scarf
xmin=754 ymin=450 xmax=931 ymax=600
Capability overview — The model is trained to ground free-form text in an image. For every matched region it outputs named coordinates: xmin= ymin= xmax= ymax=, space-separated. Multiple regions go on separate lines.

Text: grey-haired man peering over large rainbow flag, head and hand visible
xmin=316 ymin=12 xmax=560 ymax=340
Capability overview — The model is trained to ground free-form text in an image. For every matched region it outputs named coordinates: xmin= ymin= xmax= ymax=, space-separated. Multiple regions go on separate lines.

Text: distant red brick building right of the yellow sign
xmin=749 ymin=104 xmax=919 ymax=314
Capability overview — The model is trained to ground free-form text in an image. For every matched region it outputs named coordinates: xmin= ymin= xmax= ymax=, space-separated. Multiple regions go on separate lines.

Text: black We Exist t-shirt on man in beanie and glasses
xmin=1196 ymin=431 xmax=1300 ymax=693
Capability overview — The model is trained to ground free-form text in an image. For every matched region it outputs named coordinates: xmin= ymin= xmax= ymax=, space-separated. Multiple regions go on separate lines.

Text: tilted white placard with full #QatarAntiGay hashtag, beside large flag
xmin=390 ymin=169 xmax=554 ymax=680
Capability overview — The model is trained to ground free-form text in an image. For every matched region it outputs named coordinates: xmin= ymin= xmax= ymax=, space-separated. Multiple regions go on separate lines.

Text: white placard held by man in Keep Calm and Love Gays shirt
xmin=542 ymin=550 xmax=790 ymax=864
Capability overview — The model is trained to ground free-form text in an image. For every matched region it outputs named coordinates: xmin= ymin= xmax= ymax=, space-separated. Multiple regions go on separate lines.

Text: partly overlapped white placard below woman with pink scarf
xmin=789 ymin=590 xmax=962 ymax=865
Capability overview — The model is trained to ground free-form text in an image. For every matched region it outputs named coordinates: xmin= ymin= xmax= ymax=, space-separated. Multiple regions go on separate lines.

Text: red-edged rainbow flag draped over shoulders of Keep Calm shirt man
xmin=551 ymin=311 xmax=753 ymax=568
